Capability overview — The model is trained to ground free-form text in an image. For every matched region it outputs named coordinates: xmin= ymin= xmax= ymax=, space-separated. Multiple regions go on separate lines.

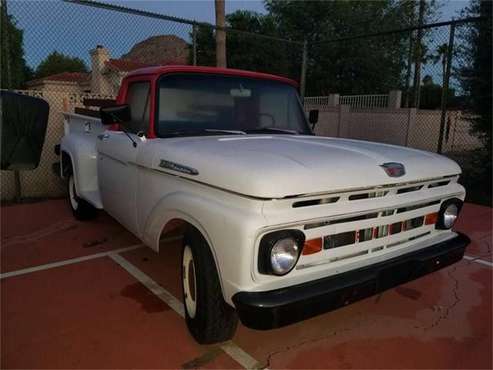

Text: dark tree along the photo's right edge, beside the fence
xmin=455 ymin=0 xmax=493 ymax=206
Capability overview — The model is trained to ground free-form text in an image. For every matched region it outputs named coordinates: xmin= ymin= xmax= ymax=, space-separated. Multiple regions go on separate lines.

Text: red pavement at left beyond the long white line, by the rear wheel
xmin=0 ymin=200 xmax=141 ymax=273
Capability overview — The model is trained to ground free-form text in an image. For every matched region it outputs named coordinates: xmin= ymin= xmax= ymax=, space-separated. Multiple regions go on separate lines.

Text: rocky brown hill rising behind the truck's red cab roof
xmin=122 ymin=35 xmax=190 ymax=65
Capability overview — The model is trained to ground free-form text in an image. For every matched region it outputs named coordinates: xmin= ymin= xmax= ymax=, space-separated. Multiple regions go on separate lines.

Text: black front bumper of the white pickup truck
xmin=233 ymin=233 xmax=470 ymax=330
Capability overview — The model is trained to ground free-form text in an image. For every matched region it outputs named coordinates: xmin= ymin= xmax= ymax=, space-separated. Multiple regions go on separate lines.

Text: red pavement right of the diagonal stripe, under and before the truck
xmin=123 ymin=233 xmax=492 ymax=369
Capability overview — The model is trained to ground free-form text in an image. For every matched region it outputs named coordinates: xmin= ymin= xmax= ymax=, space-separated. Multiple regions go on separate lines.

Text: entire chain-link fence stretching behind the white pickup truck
xmin=1 ymin=0 xmax=491 ymax=204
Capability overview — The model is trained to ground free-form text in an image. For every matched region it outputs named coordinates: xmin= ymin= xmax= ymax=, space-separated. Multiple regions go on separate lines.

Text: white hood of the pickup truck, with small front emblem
xmin=151 ymin=135 xmax=461 ymax=198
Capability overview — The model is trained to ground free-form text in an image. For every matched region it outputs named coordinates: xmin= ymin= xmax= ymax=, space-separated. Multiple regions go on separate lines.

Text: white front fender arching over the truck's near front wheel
xmin=142 ymin=190 xmax=265 ymax=303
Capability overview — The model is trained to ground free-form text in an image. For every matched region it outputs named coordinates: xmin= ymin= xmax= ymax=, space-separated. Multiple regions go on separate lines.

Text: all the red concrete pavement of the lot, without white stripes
xmin=0 ymin=201 xmax=492 ymax=368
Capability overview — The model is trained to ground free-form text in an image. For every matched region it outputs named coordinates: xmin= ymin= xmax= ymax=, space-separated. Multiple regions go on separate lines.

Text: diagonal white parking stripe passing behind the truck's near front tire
xmin=108 ymin=251 xmax=258 ymax=369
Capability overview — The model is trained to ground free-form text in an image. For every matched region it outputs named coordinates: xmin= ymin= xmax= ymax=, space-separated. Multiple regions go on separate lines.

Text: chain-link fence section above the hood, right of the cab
xmin=305 ymin=18 xmax=492 ymax=204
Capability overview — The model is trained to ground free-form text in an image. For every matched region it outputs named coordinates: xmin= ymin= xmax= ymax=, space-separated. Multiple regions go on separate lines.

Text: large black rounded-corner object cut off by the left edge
xmin=0 ymin=91 xmax=49 ymax=170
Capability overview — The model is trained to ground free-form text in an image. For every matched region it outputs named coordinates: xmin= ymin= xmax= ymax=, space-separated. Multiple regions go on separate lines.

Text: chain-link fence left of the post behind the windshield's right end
xmin=1 ymin=0 xmax=303 ymax=200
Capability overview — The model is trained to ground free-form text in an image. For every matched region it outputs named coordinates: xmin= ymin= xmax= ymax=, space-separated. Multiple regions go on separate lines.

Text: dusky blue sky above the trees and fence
xmin=7 ymin=0 xmax=468 ymax=73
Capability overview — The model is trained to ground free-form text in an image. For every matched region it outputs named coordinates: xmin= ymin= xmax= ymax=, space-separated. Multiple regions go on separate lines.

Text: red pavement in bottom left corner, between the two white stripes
xmin=1 ymin=258 xmax=242 ymax=369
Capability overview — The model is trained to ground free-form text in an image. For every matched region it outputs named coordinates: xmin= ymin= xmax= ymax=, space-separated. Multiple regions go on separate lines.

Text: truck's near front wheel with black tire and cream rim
xmin=182 ymin=228 xmax=238 ymax=344
